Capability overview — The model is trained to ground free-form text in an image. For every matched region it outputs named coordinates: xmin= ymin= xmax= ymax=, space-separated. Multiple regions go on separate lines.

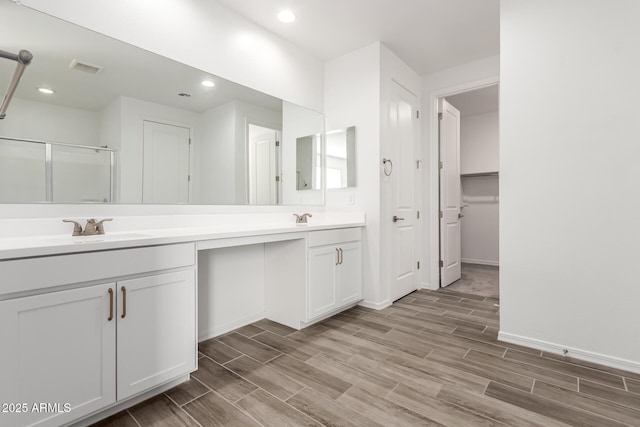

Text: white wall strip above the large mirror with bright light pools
xmin=21 ymin=0 xmax=323 ymax=110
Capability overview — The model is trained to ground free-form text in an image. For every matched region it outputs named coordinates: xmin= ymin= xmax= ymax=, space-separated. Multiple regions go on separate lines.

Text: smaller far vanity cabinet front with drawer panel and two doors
xmin=306 ymin=228 xmax=362 ymax=322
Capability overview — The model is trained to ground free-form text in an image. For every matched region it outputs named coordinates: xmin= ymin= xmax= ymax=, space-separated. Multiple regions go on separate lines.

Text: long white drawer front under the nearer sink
xmin=0 ymin=243 xmax=195 ymax=296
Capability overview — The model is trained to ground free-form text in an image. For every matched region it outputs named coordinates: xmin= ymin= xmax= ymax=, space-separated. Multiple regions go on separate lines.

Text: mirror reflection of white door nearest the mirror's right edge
xmin=249 ymin=124 xmax=280 ymax=205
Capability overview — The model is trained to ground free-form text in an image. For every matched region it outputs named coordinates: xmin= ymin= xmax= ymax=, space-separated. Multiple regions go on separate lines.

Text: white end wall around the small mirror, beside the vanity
xmin=324 ymin=43 xmax=385 ymax=305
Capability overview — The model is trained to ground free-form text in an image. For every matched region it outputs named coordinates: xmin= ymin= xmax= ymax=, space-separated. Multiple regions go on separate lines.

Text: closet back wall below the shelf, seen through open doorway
xmin=460 ymin=175 xmax=499 ymax=265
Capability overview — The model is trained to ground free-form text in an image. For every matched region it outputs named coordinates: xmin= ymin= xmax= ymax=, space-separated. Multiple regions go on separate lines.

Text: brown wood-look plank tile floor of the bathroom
xmin=98 ymin=289 xmax=640 ymax=427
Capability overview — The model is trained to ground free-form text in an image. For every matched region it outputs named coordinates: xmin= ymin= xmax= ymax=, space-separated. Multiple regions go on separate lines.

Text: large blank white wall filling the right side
xmin=500 ymin=0 xmax=640 ymax=372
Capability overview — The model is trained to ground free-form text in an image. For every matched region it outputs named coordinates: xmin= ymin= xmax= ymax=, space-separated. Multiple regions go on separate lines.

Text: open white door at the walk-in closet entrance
xmin=438 ymin=99 xmax=462 ymax=287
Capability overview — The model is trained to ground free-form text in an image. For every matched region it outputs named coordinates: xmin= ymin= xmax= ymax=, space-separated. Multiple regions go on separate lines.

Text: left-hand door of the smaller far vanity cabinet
xmin=307 ymin=246 xmax=338 ymax=320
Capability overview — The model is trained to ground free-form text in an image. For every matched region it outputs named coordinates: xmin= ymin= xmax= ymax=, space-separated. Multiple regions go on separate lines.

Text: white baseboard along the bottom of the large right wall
xmin=498 ymin=331 xmax=640 ymax=374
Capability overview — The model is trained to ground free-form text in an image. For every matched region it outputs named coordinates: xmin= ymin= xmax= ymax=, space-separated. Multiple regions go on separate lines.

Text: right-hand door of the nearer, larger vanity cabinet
xmin=117 ymin=270 xmax=197 ymax=400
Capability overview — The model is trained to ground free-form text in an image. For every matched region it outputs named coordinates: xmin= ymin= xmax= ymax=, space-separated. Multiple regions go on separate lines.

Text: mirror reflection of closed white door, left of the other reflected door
xmin=142 ymin=120 xmax=191 ymax=203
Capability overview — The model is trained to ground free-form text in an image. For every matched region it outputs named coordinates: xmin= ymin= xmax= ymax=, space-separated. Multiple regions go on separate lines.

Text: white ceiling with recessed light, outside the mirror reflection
xmin=218 ymin=0 xmax=500 ymax=75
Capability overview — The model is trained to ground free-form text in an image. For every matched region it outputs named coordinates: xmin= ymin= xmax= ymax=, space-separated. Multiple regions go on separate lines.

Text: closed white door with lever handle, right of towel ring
xmin=388 ymin=82 xmax=418 ymax=301
